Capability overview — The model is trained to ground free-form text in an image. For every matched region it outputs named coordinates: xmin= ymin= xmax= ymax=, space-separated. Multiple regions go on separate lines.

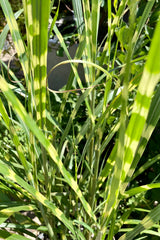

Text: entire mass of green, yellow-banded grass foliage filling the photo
xmin=0 ymin=0 xmax=160 ymax=240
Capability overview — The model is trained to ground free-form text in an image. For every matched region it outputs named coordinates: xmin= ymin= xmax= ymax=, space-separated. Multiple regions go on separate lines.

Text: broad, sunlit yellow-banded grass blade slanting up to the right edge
xmin=123 ymin=15 xmax=160 ymax=181
